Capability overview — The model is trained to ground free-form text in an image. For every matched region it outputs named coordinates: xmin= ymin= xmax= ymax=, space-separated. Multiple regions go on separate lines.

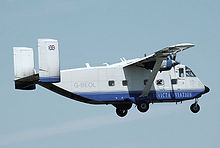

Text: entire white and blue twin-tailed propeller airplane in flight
xmin=13 ymin=39 xmax=210 ymax=117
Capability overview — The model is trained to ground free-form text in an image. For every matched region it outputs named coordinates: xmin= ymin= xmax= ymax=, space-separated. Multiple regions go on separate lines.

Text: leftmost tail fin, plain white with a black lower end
xmin=13 ymin=47 xmax=35 ymax=90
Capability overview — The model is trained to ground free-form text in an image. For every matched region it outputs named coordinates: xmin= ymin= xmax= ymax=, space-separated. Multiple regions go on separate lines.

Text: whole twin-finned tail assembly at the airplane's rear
xmin=13 ymin=39 xmax=60 ymax=90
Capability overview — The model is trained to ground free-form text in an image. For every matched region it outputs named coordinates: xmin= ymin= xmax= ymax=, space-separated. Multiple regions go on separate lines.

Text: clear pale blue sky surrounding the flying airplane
xmin=0 ymin=0 xmax=220 ymax=148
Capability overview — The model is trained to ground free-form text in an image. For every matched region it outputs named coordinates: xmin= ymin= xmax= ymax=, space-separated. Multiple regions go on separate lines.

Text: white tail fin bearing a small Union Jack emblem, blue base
xmin=38 ymin=39 xmax=60 ymax=83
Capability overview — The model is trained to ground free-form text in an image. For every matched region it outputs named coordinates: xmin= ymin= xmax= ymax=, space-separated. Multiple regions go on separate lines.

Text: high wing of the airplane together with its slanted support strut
xmin=124 ymin=43 xmax=195 ymax=97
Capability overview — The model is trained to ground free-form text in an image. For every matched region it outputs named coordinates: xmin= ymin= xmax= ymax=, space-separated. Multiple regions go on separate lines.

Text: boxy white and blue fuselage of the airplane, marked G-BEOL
xmin=54 ymin=61 xmax=205 ymax=104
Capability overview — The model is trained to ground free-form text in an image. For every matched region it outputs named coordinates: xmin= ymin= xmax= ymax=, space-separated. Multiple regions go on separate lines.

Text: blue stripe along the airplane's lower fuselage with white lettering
xmin=76 ymin=90 xmax=204 ymax=103
